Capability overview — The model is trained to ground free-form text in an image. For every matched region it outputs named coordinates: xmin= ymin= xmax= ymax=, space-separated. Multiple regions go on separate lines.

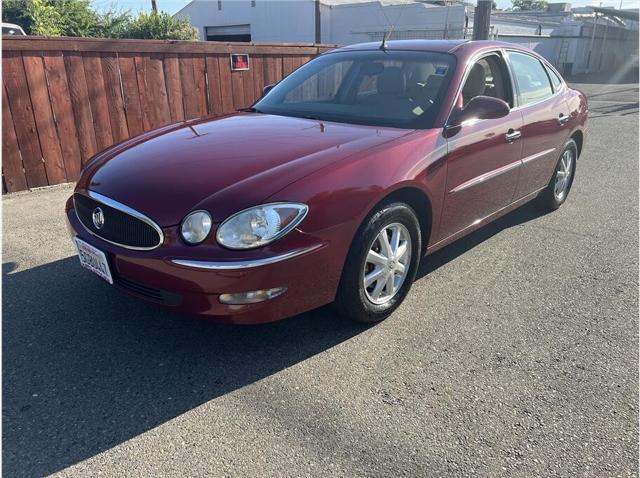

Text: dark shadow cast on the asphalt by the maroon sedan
xmin=2 ymin=200 xmax=540 ymax=476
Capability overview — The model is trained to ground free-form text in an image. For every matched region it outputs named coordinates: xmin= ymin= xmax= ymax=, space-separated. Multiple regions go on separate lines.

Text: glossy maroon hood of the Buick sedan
xmin=78 ymin=114 xmax=409 ymax=227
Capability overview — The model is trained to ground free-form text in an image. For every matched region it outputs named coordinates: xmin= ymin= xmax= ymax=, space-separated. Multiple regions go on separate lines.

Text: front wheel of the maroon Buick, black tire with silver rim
xmin=335 ymin=202 xmax=422 ymax=322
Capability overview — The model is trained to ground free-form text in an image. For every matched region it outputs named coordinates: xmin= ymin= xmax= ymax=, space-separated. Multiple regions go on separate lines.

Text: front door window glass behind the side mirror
xmin=459 ymin=55 xmax=513 ymax=107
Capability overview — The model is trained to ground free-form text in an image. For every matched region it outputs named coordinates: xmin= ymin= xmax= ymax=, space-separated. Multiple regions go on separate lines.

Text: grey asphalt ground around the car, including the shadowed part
xmin=2 ymin=78 xmax=638 ymax=477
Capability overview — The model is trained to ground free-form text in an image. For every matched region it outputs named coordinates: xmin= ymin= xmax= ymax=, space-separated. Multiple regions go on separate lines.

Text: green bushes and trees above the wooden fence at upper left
xmin=2 ymin=0 xmax=198 ymax=40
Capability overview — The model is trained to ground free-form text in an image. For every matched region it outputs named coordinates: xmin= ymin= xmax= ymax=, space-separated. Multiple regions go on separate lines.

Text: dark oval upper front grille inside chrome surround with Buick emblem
xmin=73 ymin=193 xmax=162 ymax=249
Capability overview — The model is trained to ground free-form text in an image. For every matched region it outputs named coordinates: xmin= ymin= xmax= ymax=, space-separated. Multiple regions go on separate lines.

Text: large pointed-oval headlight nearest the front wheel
xmin=216 ymin=203 xmax=309 ymax=249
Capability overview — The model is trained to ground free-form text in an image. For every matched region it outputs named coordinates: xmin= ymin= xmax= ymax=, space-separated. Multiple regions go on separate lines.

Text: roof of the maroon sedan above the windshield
xmin=331 ymin=40 xmax=529 ymax=55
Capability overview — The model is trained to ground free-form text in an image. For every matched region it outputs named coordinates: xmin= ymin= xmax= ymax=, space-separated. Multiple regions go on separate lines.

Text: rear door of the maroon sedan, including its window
xmin=508 ymin=50 xmax=569 ymax=199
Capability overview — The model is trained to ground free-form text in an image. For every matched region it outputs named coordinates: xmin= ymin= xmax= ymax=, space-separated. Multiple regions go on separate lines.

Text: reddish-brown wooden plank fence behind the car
xmin=2 ymin=37 xmax=331 ymax=192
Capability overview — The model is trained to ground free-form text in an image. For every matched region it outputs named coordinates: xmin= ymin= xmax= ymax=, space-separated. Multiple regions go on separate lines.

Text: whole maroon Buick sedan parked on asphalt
xmin=66 ymin=40 xmax=587 ymax=324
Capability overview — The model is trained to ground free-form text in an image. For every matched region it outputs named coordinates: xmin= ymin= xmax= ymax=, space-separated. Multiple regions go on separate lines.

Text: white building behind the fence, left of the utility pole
xmin=176 ymin=0 xmax=465 ymax=45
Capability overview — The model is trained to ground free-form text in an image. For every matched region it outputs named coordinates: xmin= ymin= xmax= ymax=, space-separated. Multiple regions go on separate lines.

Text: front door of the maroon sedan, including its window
xmin=438 ymin=52 xmax=523 ymax=240
